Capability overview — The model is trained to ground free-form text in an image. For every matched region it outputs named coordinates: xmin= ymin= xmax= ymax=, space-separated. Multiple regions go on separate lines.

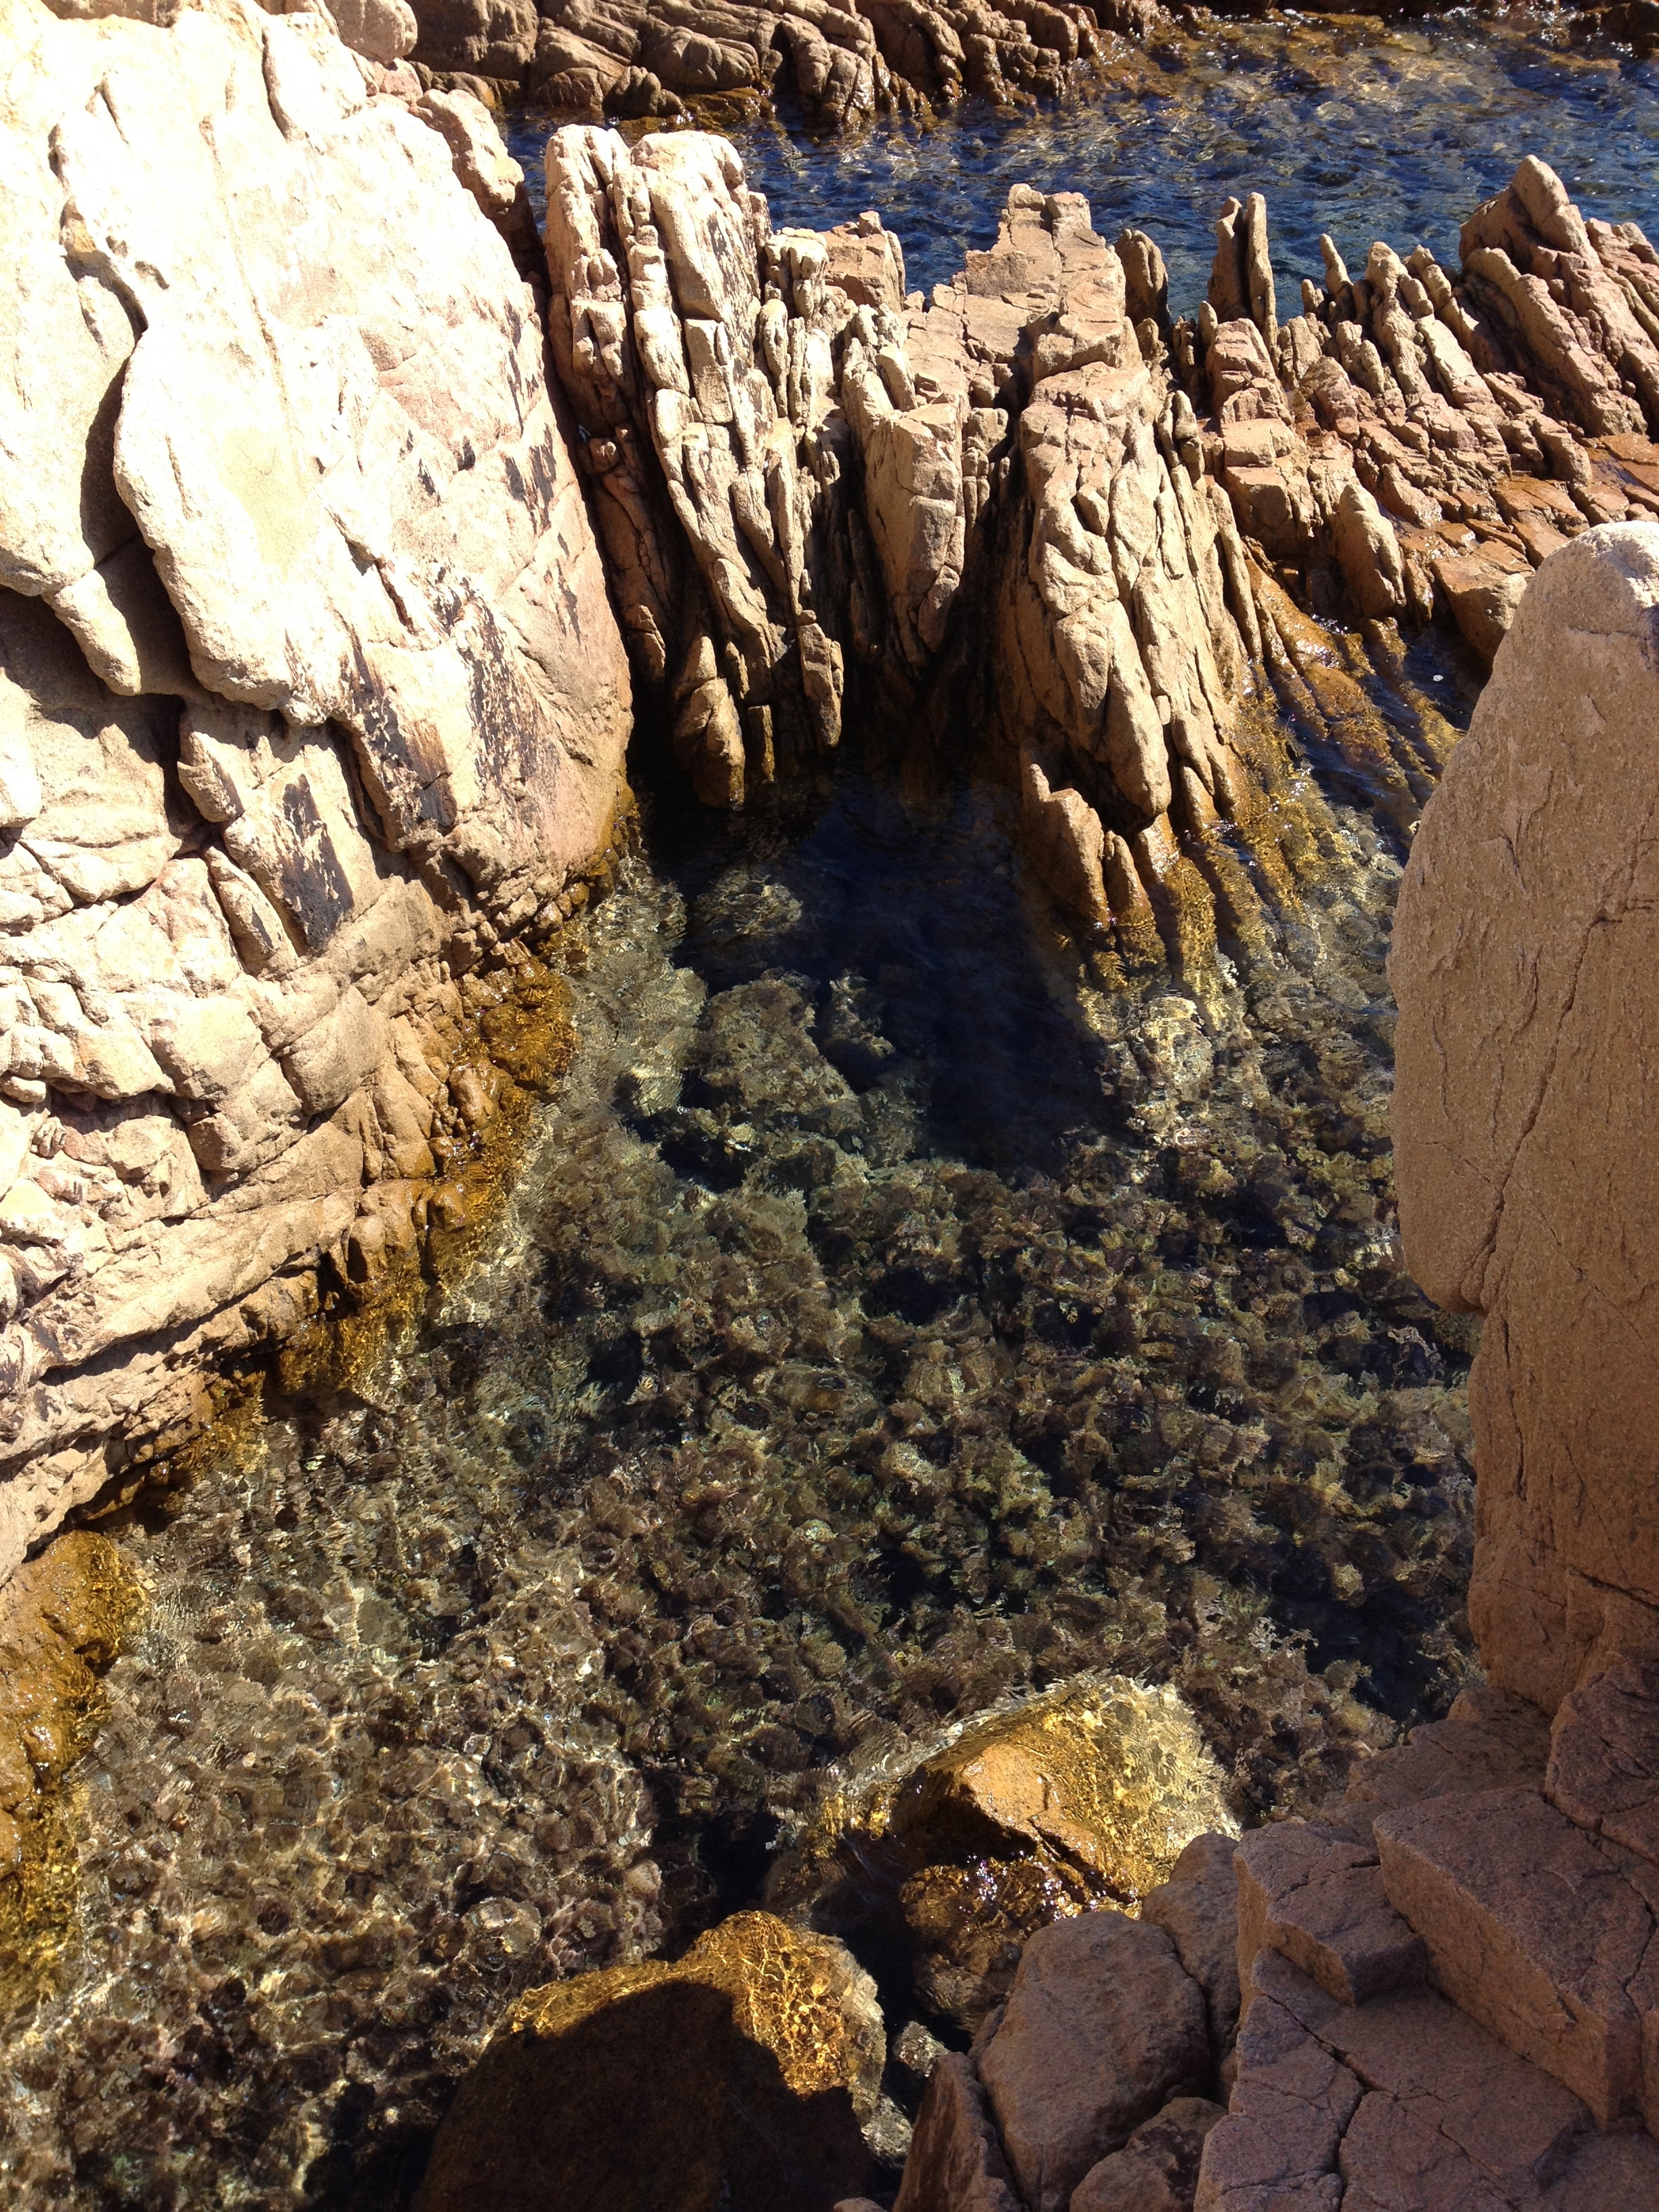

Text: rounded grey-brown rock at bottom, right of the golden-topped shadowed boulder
xmin=980 ymin=1911 xmax=1210 ymax=2212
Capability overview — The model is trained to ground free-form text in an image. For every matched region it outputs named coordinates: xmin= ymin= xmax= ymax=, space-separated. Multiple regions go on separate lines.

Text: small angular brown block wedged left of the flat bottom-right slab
xmin=1234 ymin=1820 xmax=1427 ymax=2004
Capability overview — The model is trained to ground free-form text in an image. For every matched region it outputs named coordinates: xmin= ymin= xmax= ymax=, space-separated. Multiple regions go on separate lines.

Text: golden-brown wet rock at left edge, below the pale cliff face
xmin=0 ymin=1528 xmax=146 ymax=2011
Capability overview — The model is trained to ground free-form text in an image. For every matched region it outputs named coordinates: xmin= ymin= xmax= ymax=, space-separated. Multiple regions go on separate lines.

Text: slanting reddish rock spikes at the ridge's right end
xmin=1172 ymin=157 xmax=1659 ymax=659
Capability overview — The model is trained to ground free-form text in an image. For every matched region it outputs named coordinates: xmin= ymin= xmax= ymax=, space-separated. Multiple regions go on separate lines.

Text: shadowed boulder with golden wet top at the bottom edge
xmin=416 ymin=1913 xmax=884 ymax=2212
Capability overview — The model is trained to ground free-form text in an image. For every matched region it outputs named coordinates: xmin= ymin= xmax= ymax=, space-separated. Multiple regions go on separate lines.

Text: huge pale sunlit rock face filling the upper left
xmin=0 ymin=0 xmax=628 ymax=1573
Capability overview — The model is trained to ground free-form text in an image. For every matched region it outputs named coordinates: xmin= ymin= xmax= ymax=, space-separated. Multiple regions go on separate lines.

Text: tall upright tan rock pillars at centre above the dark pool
xmin=546 ymin=128 xmax=1327 ymax=927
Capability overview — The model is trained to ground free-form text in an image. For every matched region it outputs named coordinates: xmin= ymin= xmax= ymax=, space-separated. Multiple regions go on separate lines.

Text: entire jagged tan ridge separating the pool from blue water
xmin=546 ymin=128 xmax=1659 ymax=966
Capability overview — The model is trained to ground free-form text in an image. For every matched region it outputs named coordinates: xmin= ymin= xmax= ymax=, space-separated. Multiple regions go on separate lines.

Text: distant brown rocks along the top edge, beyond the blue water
xmin=413 ymin=0 xmax=1132 ymax=131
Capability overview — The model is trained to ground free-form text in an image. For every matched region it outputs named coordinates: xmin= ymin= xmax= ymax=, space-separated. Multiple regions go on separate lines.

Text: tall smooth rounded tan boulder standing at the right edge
xmin=1389 ymin=525 xmax=1659 ymax=1712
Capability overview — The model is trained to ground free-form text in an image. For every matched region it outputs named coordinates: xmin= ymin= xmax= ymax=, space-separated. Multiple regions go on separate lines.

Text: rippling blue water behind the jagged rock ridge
xmin=509 ymin=11 xmax=1659 ymax=312
